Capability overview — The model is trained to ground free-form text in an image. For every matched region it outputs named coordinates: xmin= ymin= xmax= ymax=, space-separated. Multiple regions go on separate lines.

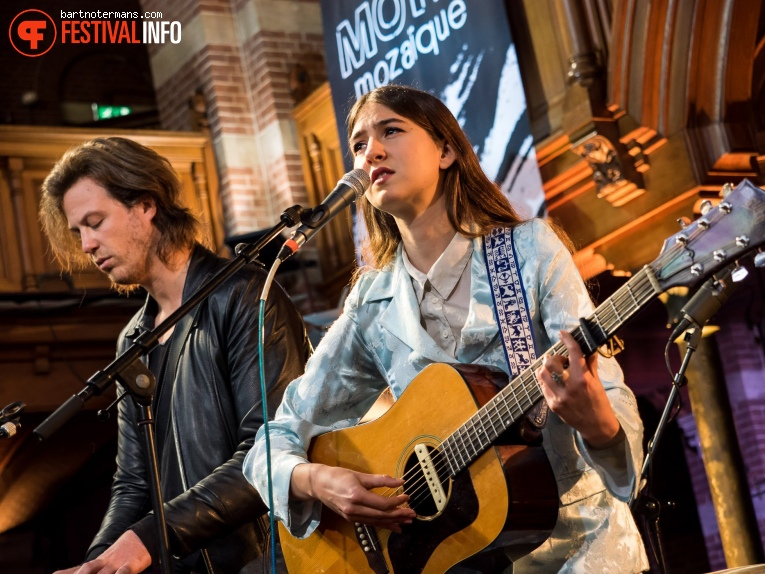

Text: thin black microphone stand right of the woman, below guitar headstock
xmin=629 ymin=323 xmax=702 ymax=574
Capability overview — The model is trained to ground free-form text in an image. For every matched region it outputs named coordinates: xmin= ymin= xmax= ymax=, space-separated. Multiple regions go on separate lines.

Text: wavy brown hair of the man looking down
xmin=40 ymin=137 xmax=200 ymax=271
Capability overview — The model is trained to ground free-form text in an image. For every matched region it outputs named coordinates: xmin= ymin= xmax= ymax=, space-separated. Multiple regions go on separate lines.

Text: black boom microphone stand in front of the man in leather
xmin=32 ymin=205 xmax=310 ymax=574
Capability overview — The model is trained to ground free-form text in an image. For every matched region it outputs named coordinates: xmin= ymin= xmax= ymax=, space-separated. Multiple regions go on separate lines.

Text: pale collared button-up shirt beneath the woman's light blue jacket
xmin=401 ymin=233 xmax=473 ymax=357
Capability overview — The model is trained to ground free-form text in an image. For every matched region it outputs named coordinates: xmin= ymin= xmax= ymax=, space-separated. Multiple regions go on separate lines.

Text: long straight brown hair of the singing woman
xmin=347 ymin=85 xmax=521 ymax=269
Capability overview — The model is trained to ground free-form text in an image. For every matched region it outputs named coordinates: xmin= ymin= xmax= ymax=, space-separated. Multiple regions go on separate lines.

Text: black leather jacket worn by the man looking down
xmin=88 ymin=246 xmax=311 ymax=574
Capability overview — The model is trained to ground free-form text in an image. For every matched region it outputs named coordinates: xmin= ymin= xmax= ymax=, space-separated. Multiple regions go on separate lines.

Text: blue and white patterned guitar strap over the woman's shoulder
xmin=483 ymin=227 xmax=548 ymax=436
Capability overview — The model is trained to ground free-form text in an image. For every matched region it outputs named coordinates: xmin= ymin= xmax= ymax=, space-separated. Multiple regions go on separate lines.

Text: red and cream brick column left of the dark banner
xmin=141 ymin=0 xmax=326 ymax=235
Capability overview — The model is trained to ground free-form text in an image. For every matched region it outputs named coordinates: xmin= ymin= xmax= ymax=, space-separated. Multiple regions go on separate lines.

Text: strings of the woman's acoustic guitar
xmin=374 ymin=264 xmax=664 ymax=511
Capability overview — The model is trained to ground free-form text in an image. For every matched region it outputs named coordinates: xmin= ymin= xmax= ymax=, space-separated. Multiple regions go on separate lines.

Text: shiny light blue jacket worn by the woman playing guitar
xmin=243 ymin=220 xmax=648 ymax=573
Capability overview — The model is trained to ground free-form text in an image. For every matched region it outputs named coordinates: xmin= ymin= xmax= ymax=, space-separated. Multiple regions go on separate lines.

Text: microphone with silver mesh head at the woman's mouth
xmin=277 ymin=169 xmax=372 ymax=263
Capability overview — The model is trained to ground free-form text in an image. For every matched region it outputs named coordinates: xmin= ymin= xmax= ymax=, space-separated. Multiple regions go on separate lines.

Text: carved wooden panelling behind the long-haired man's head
xmin=0 ymin=126 xmax=224 ymax=293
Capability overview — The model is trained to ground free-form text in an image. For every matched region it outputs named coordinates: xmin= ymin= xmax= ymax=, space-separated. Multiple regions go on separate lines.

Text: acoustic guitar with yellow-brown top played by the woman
xmin=279 ymin=180 xmax=765 ymax=574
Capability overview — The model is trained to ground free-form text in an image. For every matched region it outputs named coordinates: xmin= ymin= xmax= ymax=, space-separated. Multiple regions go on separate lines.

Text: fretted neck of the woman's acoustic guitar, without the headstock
xmin=441 ymin=266 xmax=662 ymax=476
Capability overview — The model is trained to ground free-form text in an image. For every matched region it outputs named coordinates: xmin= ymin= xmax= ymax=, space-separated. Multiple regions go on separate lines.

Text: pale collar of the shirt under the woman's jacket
xmin=401 ymin=233 xmax=473 ymax=302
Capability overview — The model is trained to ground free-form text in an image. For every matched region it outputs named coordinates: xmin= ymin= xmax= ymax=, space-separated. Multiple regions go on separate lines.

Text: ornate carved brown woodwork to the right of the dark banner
xmin=508 ymin=0 xmax=765 ymax=275
